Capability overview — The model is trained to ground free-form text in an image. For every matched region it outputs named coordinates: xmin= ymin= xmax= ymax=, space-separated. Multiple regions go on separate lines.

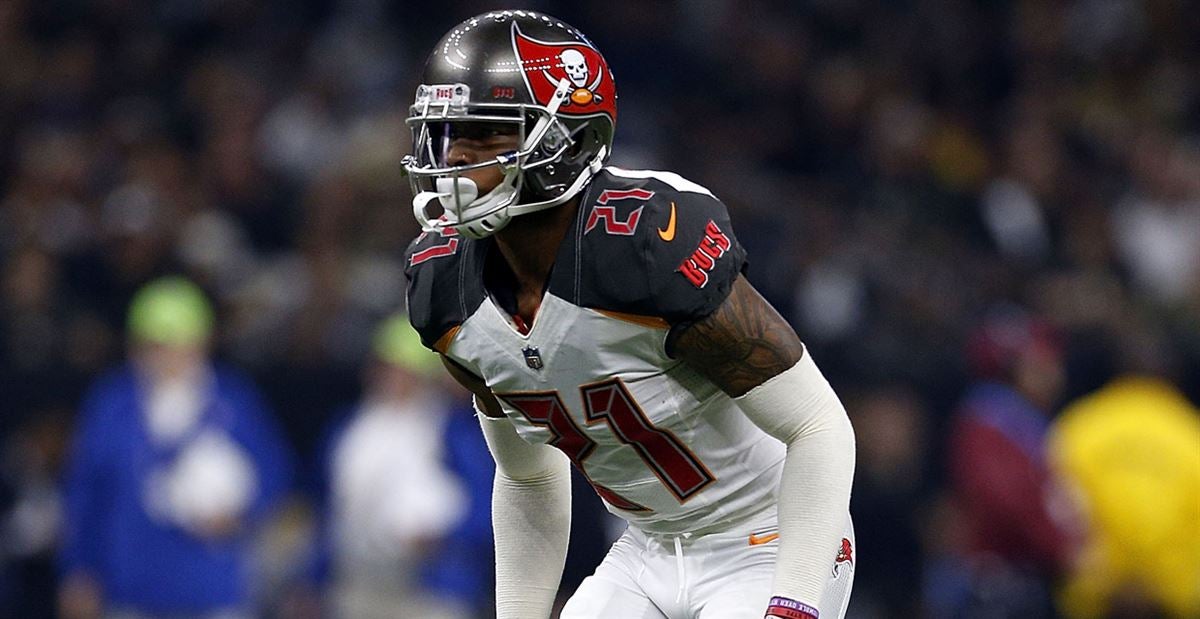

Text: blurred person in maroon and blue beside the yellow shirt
xmin=926 ymin=306 xmax=1079 ymax=617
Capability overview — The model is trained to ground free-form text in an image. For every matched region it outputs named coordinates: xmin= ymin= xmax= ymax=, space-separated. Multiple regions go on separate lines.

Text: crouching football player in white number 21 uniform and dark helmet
xmin=404 ymin=11 xmax=857 ymax=619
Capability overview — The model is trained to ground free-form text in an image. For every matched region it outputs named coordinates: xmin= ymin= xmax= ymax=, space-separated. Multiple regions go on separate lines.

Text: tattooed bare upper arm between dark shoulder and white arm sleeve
xmin=671 ymin=277 xmax=804 ymax=397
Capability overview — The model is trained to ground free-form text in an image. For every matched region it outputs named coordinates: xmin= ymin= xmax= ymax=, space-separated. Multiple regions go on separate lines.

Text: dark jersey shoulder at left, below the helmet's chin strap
xmin=404 ymin=230 xmax=484 ymax=350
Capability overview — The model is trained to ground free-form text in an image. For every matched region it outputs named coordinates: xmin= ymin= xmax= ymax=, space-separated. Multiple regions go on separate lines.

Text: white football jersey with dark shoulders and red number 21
xmin=407 ymin=168 xmax=785 ymax=534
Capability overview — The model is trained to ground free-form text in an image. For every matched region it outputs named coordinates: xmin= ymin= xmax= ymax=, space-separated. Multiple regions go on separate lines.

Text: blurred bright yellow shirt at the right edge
xmin=1050 ymin=377 xmax=1200 ymax=617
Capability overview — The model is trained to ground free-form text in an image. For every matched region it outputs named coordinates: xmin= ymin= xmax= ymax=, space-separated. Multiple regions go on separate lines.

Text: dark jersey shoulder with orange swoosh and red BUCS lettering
xmin=564 ymin=168 xmax=746 ymax=324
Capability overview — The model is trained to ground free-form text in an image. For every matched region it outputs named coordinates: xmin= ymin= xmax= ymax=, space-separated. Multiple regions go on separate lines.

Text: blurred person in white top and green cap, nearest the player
xmin=320 ymin=314 xmax=472 ymax=619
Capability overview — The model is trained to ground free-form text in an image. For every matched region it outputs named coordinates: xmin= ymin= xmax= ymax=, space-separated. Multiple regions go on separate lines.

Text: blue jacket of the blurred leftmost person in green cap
xmin=60 ymin=366 xmax=292 ymax=613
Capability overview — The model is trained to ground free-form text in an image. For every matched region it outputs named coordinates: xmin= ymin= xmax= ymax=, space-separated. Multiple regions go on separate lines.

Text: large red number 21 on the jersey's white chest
xmin=497 ymin=378 xmax=716 ymax=511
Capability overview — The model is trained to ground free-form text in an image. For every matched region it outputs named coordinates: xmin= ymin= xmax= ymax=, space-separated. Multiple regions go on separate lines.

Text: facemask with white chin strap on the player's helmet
xmin=403 ymin=79 xmax=605 ymax=239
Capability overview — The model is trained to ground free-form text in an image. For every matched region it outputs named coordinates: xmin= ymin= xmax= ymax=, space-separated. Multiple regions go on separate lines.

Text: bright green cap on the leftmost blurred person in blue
xmin=128 ymin=277 xmax=212 ymax=345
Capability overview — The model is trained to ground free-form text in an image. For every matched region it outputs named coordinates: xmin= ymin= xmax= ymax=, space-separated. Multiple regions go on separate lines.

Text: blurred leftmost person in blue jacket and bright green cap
xmin=59 ymin=277 xmax=290 ymax=619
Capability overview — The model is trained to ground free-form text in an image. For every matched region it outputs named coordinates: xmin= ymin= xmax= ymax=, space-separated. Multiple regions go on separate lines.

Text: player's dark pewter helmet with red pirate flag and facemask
xmin=403 ymin=11 xmax=617 ymax=239
